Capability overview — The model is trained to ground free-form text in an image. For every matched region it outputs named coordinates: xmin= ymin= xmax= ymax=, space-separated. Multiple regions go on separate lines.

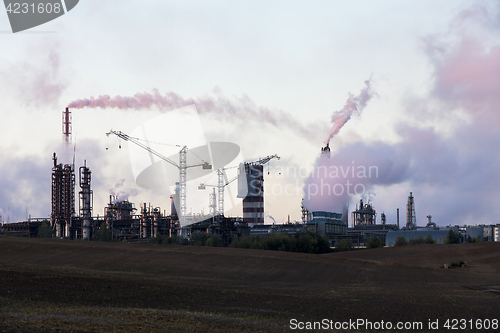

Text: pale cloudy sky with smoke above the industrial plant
xmin=0 ymin=0 xmax=500 ymax=226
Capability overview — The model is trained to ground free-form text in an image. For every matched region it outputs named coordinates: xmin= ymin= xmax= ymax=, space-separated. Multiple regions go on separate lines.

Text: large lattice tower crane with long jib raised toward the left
xmin=106 ymin=130 xmax=212 ymax=225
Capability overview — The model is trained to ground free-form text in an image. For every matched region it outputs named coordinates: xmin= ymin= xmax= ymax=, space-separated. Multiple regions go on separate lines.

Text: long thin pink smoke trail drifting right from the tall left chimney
xmin=68 ymin=89 xmax=322 ymax=142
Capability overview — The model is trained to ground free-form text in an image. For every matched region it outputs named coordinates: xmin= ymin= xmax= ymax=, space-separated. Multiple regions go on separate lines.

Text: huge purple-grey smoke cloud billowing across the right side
xmin=304 ymin=3 xmax=500 ymax=225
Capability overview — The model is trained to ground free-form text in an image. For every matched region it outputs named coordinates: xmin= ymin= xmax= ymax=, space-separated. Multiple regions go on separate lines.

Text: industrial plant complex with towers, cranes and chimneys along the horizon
xmin=0 ymin=108 xmax=500 ymax=247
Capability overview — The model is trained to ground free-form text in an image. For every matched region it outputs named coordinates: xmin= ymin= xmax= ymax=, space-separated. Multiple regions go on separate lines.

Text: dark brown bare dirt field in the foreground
xmin=0 ymin=236 xmax=500 ymax=332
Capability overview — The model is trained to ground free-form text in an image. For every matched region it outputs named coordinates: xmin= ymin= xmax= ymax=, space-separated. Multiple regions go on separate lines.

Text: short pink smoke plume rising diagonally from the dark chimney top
xmin=325 ymin=79 xmax=373 ymax=145
